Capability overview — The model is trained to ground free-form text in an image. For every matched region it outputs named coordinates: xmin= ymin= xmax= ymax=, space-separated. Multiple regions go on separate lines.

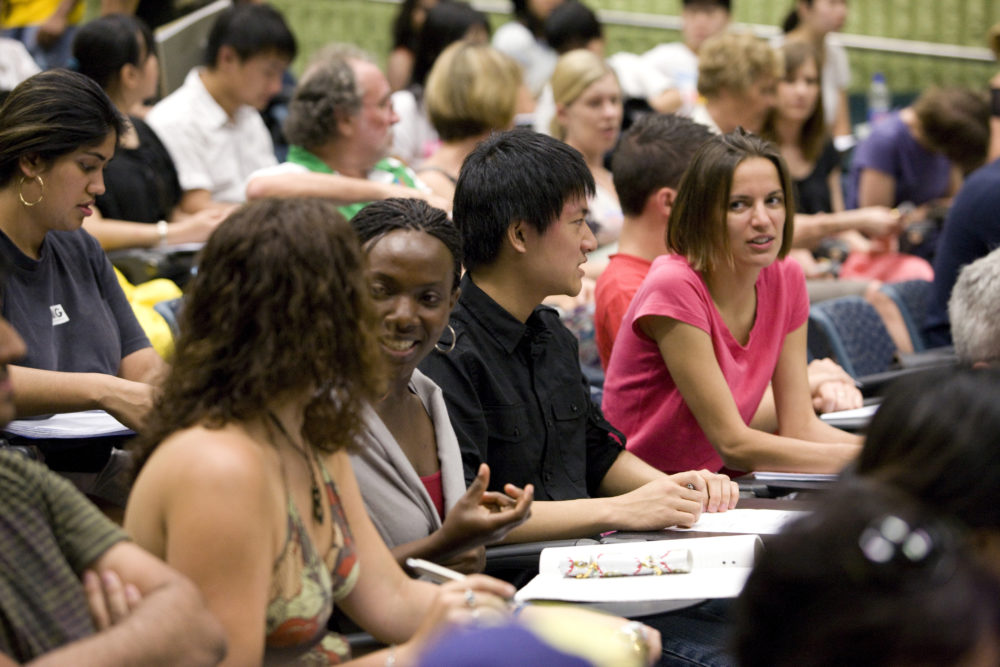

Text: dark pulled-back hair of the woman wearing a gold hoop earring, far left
xmin=0 ymin=69 xmax=125 ymax=187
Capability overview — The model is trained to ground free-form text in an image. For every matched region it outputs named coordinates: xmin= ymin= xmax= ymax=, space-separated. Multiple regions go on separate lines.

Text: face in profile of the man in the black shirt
xmin=524 ymin=196 xmax=597 ymax=296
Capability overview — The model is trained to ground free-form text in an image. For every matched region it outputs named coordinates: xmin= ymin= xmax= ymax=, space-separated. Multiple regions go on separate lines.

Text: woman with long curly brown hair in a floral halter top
xmin=125 ymin=199 xmax=513 ymax=665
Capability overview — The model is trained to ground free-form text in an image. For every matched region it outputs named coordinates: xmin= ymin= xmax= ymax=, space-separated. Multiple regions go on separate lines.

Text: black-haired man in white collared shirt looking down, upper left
xmin=146 ymin=4 xmax=296 ymax=212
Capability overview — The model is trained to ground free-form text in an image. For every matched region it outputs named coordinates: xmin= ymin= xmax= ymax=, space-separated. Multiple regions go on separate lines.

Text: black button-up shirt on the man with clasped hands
xmin=420 ymin=275 xmax=625 ymax=500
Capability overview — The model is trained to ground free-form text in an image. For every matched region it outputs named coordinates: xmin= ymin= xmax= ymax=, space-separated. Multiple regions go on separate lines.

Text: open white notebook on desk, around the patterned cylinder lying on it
xmin=514 ymin=535 xmax=763 ymax=613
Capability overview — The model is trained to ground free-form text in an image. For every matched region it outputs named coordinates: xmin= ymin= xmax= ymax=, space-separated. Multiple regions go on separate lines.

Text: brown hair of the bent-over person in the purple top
xmin=913 ymin=86 xmax=990 ymax=175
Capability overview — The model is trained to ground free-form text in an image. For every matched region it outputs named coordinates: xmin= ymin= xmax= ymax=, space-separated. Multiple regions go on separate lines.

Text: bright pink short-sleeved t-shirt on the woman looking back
xmin=603 ymin=255 xmax=809 ymax=473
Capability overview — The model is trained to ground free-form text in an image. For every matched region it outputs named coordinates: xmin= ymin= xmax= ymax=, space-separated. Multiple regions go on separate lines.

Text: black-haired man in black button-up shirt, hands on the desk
xmin=420 ymin=130 xmax=738 ymax=542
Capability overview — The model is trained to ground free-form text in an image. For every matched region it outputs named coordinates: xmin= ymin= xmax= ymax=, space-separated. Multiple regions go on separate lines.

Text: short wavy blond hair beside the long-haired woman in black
xmin=698 ymin=33 xmax=784 ymax=99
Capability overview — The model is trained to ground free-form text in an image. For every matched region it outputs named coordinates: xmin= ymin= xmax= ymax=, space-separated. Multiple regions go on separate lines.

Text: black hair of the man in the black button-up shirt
xmin=452 ymin=129 xmax=594 ymax=271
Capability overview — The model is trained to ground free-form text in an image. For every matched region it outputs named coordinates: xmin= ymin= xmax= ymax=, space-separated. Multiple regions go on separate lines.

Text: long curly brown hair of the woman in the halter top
xmin=137 ymin=198 xmax=382 ymax=465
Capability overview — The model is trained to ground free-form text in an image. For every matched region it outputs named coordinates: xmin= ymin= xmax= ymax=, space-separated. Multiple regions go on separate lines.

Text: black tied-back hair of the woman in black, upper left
xmin=73 ymin=14 xmax=155 ymax=90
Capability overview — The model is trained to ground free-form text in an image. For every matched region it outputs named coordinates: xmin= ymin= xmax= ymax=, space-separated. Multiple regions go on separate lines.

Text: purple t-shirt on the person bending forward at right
xmin=846 ymin=111 xmax=951 ymax=208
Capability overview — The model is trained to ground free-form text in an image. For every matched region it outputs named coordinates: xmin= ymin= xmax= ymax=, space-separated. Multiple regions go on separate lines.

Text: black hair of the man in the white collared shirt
xmin=204 ymin=4 xmax=297 ymax=68
